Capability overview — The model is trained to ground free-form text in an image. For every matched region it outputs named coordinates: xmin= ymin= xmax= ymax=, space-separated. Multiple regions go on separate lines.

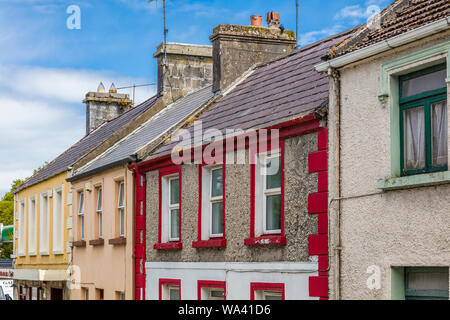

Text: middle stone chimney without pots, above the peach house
xmin=153 ymin=42 xmax=212 ymax=102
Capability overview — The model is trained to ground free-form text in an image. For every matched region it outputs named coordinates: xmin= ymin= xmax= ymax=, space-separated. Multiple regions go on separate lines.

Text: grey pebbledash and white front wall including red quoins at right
xmin=138 ymin=121 xmax=328 ymax=300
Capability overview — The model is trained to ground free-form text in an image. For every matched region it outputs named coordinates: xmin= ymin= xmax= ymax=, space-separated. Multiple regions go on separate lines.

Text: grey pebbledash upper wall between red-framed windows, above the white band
xmin=146 ymin=133 xmax=317 ymax=262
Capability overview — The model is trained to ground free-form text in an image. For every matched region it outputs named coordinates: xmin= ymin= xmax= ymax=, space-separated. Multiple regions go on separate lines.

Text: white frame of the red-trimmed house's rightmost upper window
xmin=255 ymin=149 xmax=282 ymax=236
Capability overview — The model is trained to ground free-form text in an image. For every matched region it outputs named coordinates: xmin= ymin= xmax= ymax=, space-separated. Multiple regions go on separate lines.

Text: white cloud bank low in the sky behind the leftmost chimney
xmin=0 ymin=65 xmax=155 ymax=194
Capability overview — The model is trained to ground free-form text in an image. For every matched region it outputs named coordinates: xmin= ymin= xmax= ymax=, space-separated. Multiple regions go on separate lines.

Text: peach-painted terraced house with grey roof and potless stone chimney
xmin=67 ymin=43 xmax=218 ymax=300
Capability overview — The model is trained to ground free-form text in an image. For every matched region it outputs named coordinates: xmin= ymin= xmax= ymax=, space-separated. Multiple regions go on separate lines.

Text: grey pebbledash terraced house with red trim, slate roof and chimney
xmin=133 ymin=17 xmax=356 ymax=300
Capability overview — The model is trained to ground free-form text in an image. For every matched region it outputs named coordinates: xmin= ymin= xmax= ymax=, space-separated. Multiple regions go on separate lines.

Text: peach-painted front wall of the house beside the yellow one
xmin=71 ymin=167 xmax=134 ymax=300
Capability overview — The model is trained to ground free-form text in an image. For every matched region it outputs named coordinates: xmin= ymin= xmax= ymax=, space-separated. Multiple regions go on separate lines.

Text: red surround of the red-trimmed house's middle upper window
xmin=192 ymin=153 xmax=227 ymax=248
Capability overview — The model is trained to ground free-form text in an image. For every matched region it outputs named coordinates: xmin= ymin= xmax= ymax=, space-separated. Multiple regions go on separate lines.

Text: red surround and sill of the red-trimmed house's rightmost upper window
xmin=244 ymin=138 xmax=286 ymax=246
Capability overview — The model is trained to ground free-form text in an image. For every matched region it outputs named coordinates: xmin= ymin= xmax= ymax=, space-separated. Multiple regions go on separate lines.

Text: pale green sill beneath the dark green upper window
xmin=377 ymin=171 xmax=450 ymax=191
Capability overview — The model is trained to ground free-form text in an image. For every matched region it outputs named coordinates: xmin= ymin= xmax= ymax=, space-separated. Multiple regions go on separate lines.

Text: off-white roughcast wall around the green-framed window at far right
xmin=329 ymin=32 xmax=450 ymax=299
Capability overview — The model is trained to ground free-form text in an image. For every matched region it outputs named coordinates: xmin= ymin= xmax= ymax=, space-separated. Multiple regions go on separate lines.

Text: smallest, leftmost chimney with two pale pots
xmin=83 ymin=82 xmax=133 ymax=135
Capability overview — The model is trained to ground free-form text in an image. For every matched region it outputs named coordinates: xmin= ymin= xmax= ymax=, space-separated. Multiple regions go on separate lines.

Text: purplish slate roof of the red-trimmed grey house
xmin=149 ymin=30 xmax=352 ymax=159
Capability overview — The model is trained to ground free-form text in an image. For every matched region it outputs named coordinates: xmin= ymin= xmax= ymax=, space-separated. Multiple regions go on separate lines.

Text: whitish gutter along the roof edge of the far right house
xmin=315 ymin=16 xmax=450 ymax=72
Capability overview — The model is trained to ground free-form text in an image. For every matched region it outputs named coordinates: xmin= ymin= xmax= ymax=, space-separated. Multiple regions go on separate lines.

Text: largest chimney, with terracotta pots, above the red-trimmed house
xmin=209 ymin=12 xmax=296 ymax=92
